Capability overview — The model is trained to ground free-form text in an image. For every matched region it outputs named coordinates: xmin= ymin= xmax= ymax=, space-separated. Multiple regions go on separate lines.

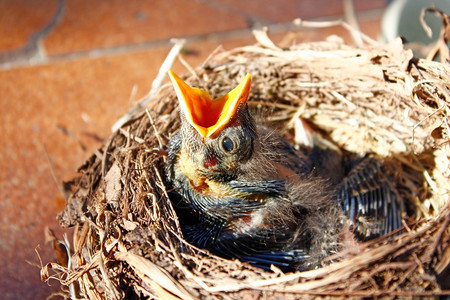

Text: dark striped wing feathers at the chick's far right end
xmin=337 ymin=157 xmax=401 ymax=240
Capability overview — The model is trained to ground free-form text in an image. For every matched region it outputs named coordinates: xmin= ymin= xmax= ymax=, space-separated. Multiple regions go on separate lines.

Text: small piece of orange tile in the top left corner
xmin=0 ymin=0 xmax=58 ymax=54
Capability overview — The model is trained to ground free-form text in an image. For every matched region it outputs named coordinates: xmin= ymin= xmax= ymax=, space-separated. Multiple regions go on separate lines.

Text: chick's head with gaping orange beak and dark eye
xmin=169 ymin=71 xmax=256 ymax=180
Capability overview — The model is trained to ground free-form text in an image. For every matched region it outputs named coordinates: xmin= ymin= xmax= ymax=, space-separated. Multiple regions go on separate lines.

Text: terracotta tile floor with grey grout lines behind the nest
xmin=0 ymin=0 xmax=385 ymax=299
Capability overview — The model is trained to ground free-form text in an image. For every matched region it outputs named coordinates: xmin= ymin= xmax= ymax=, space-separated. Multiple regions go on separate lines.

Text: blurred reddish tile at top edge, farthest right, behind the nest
xmin=217 ymin=0 xmax=386 ymax=23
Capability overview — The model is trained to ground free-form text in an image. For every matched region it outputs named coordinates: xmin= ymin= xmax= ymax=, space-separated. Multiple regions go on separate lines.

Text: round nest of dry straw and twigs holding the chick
xmin=41 ymin=29 xmax=450 ymax=299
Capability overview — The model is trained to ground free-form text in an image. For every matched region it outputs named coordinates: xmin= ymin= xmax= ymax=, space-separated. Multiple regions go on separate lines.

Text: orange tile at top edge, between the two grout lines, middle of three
xmin=44 ymin=0 xmax=248 ymax=55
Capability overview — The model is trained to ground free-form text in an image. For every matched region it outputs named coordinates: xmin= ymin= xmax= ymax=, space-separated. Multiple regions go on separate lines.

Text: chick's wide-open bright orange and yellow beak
xmin=169 ymin=71 xmax=251 ymax=138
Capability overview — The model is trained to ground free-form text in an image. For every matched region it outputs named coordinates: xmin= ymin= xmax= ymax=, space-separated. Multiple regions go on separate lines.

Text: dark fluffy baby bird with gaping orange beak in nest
xmin=166 ymin=71 xmax=401 ymax=271
